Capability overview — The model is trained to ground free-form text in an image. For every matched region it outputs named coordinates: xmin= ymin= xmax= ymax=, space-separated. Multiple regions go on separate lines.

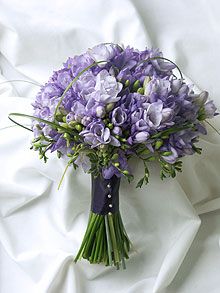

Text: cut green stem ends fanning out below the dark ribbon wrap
xmin=74 ymin=211 xmax=131 ymax=269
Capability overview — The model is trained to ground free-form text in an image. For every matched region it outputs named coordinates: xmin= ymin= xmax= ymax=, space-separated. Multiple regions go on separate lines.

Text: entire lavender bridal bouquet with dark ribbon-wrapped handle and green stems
xmin=10 ymin=43 xmax=217 ymax=268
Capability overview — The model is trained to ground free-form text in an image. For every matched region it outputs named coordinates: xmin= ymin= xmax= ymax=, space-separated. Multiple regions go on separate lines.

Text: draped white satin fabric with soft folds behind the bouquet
xmin=0 ymin=0 xmax=220 ymax=293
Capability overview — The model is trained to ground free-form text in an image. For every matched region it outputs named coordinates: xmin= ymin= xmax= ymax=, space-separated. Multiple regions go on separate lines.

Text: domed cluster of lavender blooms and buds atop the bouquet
xmin=33 ymin=44 xmax=217 ymax=178
